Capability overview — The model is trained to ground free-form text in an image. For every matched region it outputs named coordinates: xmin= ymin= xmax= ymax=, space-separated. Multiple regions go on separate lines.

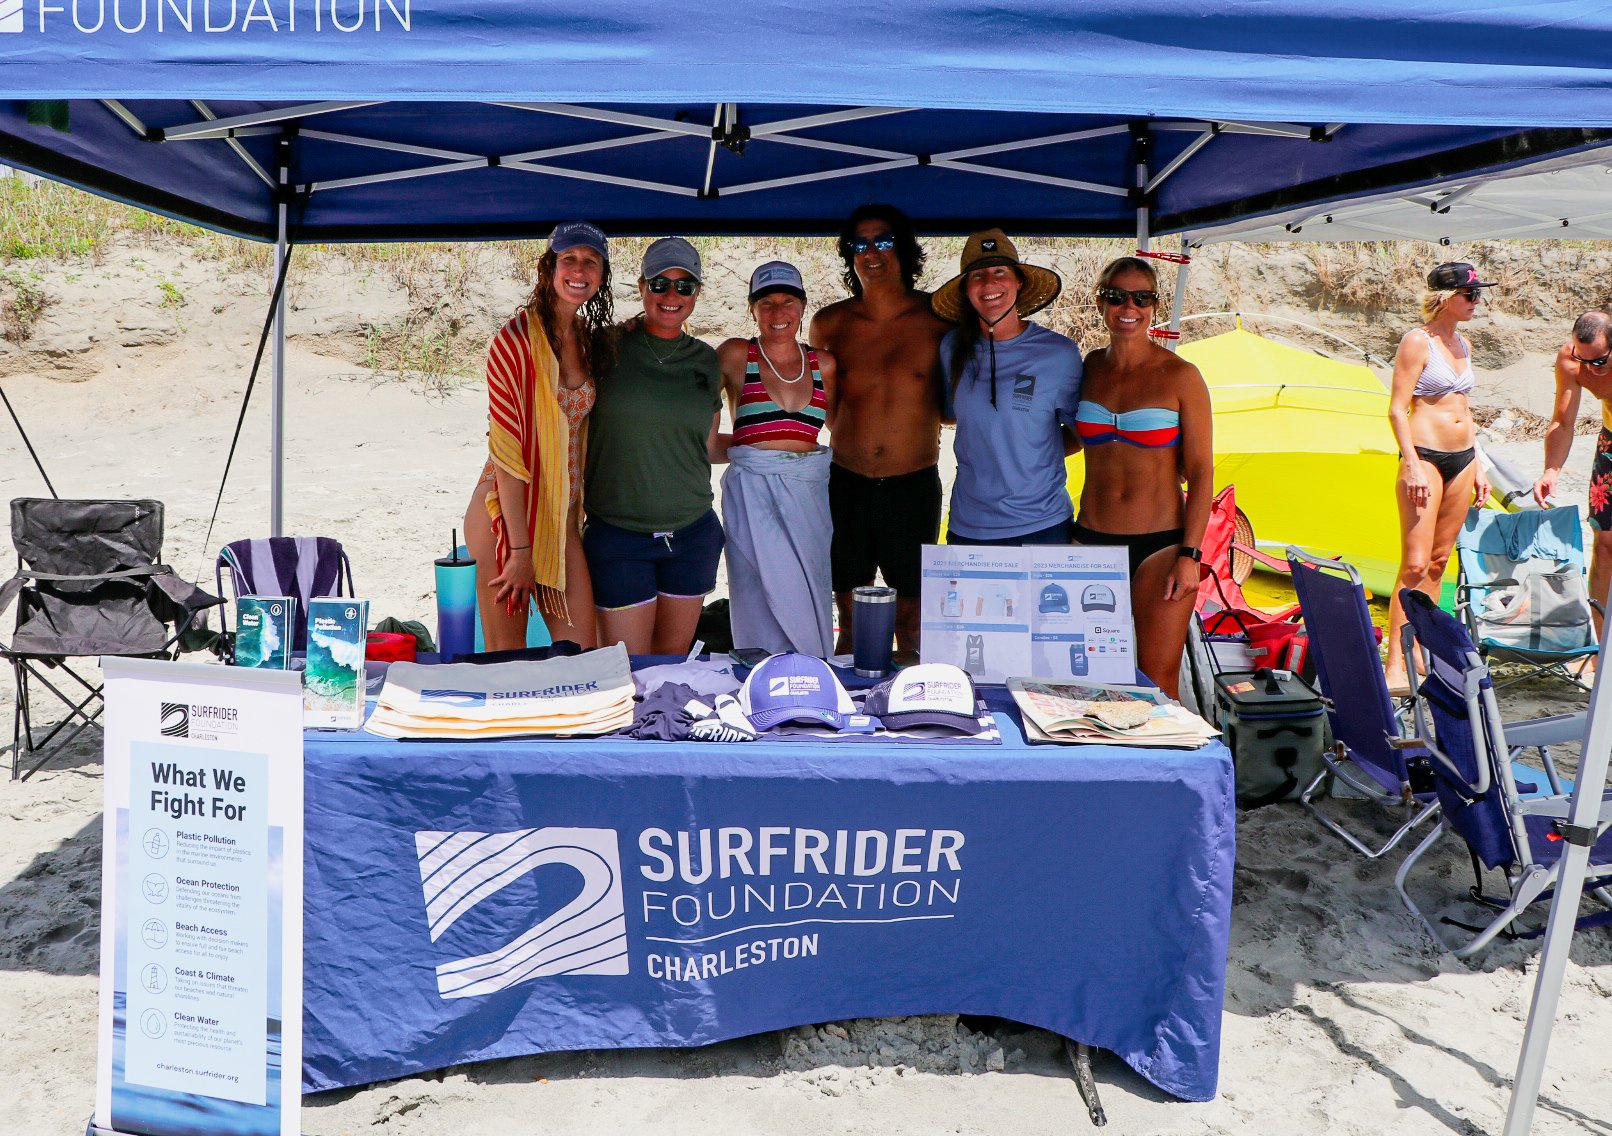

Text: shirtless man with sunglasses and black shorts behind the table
xmin=811 ymin=205 xmax=951 ymax=654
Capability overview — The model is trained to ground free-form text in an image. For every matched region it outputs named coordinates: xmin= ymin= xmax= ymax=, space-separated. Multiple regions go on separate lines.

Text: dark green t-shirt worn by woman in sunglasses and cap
xmin=585 ymin=330 xmax=722 ymax=532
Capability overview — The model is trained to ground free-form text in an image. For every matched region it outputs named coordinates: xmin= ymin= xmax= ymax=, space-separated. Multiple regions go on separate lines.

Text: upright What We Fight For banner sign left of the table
xmin=95 ymin=659 xmax=303 ymax=1136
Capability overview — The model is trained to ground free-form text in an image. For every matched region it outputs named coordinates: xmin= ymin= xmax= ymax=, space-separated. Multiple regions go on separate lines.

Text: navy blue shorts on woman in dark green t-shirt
xmin=582 ymin=511 xmax=725 ymax=611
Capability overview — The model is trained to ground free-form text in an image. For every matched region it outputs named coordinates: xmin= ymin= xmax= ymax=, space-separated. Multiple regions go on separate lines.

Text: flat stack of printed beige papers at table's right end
xmin=1008 ymin=678 xmax=1219 ymax=749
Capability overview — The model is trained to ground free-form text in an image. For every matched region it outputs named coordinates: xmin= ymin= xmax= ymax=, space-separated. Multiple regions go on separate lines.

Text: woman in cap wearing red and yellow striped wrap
xmin=464 ymin=221 xmax=614 ymax=651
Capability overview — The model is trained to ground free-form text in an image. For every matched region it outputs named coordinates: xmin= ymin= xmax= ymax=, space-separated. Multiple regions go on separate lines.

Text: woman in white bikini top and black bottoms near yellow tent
xmin=1385 ymin=261 xmax=1494 ymax=694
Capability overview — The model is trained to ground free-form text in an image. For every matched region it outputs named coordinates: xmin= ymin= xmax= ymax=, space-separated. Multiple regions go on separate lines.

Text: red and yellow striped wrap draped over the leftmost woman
xmin=487 ymin=311 xmax=588 ymax=622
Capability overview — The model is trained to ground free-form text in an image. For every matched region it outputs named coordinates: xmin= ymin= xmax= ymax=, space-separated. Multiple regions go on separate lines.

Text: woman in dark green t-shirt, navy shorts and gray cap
xmin=582 ymin=237 xmax=727 ymax=654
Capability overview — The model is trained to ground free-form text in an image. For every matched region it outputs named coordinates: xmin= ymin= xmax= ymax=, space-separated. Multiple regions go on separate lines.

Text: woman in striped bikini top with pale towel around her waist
xmin=717 ymin=261 xmax=835 ymax=659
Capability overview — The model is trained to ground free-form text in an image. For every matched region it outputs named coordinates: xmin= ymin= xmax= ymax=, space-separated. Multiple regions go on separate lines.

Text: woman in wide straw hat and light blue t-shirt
xmin=930 ymin=229 xmax=1080 ymax=545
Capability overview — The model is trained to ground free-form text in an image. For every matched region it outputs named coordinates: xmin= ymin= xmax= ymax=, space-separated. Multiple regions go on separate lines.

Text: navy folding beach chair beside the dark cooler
xmin=1288 ymin=546 xmax=1438 ymax=860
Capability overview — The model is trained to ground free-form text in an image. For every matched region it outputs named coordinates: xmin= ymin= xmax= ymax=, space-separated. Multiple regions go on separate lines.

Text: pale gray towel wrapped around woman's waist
xmin=722 ymin=446 xmax=833 ymax=659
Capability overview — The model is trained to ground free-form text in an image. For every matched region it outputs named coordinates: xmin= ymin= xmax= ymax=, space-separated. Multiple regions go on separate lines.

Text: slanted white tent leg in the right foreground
xmin=1504 ymin=625 xmax=1612 ymax=1136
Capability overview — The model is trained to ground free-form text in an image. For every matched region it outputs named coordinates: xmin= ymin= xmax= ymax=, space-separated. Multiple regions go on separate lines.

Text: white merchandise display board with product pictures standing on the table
xmin=919 ymin=545 xmax=1136 ymax=683
